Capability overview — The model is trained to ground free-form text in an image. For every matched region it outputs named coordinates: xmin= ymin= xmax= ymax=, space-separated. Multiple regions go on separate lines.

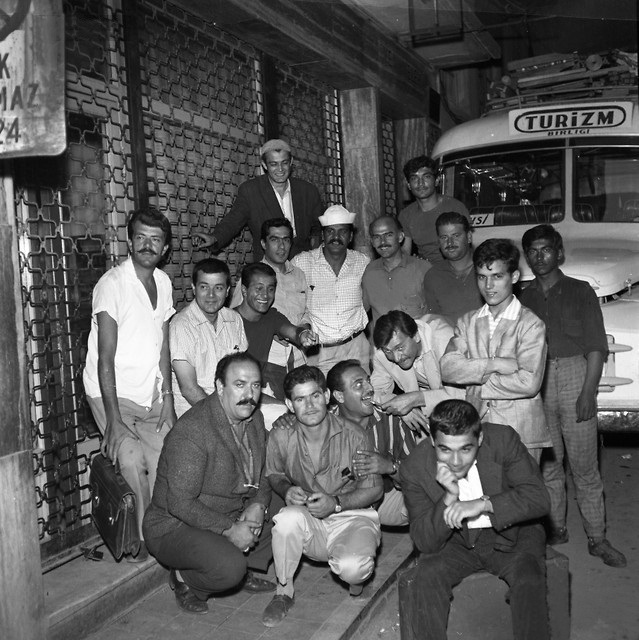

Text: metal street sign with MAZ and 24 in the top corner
xmin=0 ymin=0 xmax=66 ymax=159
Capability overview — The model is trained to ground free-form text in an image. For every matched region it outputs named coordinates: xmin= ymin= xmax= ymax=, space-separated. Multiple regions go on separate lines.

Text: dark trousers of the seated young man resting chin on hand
xmin=410 ymin=530 xmax=550 ymax=640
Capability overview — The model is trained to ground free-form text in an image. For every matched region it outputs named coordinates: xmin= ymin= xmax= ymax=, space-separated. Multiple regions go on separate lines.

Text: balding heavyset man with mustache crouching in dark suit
xmin=144 ymin=352 xmax=275 ymax=614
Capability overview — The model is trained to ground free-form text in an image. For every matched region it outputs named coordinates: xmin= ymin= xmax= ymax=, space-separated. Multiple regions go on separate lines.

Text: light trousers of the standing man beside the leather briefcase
xmin=87 ymin=397 xmax=169 ymax=539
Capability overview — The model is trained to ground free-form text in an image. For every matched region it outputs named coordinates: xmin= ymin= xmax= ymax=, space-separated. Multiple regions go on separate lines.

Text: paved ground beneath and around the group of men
xmin=82 ymin=436 xmax=639 ymax=640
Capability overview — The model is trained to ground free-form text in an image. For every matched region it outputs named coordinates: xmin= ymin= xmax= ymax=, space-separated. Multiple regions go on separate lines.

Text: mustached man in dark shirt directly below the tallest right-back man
xmin=423 ymin=211 xmax=483 ymax=326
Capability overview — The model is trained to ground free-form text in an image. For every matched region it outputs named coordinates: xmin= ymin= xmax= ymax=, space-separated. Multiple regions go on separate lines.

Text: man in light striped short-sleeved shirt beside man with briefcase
xmin=169 ymin=258 xmax=248 ymax=418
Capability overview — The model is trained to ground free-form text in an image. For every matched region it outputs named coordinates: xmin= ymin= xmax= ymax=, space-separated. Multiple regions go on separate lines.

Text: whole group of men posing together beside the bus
xmin=84 ymin=140 xmax=625 ymax=638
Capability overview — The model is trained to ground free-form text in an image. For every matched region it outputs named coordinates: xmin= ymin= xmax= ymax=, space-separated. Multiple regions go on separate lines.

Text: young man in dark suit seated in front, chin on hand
xmin=400 ymin=400 xmax=550 ymax=640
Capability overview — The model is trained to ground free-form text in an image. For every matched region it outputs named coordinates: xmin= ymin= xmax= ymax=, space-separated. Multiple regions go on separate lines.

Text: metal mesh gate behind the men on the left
xmin=14 ymin=0 xmax=342 ymax=568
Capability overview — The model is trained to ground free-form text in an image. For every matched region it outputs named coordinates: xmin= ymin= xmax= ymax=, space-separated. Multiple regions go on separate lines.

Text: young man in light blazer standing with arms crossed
xmin=441 ymin=239 xmax=551 ymax=461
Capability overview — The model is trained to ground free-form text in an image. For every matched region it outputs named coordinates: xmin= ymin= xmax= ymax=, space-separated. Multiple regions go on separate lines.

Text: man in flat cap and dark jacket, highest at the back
xmin=196 ymin=139 xmax=324 ymax=261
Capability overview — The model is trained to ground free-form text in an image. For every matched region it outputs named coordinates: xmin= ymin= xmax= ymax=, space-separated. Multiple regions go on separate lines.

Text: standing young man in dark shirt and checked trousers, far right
xmin=521 ymin=224 xmax=626 ymax=567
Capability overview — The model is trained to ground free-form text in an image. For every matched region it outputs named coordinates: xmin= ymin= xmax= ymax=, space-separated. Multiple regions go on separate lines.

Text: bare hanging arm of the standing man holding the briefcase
xmin=97 ymin=311 xmax=138 ymax=462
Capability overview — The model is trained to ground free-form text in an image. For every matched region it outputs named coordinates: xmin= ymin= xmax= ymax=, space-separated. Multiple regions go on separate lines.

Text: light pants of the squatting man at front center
xmin=272 ymin=506 xmax=381 ymax=597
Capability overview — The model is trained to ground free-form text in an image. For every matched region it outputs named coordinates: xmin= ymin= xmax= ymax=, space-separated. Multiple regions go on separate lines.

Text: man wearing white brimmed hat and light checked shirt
xmin=291 ymin=205 xmax=370 ymax=375
